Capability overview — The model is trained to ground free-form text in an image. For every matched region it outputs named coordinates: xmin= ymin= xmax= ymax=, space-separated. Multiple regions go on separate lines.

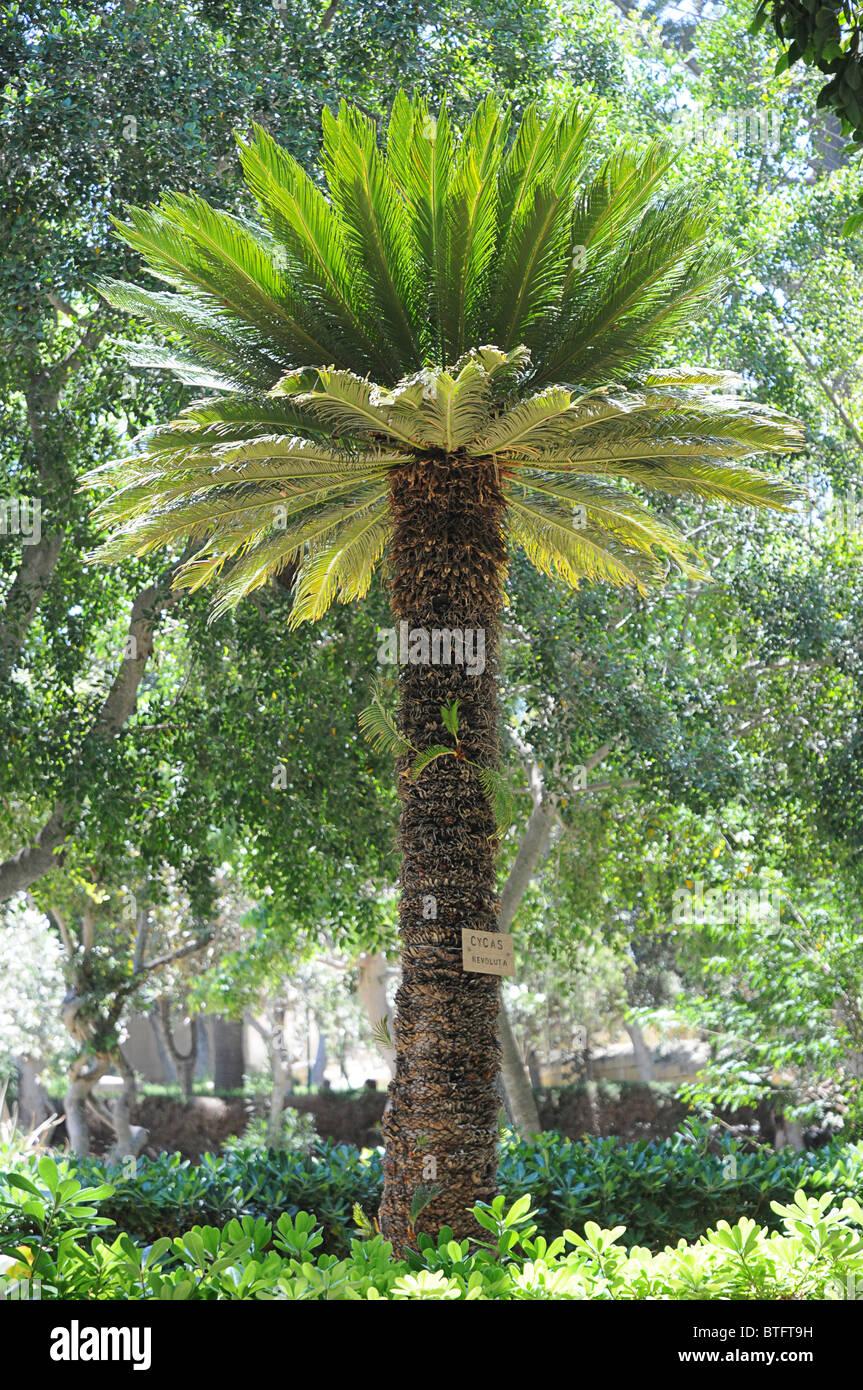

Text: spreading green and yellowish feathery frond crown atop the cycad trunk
xmin=88 ymin=95 xmax=799 ymax=624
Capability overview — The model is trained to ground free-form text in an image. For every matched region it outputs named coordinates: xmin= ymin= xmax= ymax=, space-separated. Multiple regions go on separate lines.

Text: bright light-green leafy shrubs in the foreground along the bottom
xmin=0 ymin=1156 xmax=863 ymax=1301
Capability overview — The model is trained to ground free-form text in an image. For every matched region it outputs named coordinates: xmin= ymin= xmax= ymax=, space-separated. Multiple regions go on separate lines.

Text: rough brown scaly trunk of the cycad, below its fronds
xmin=379 ymin=456 xmax=506 ymax=1254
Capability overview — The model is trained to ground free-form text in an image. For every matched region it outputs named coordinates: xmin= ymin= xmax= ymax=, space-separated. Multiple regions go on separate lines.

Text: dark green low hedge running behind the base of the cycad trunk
xmin=63 ymin=1133 xmax=863 ymax=1255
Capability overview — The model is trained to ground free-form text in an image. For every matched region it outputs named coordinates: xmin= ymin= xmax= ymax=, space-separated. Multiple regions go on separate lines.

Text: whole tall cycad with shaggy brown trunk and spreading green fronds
xmin=92 ymin=96 xmax=798 ymax=1250
